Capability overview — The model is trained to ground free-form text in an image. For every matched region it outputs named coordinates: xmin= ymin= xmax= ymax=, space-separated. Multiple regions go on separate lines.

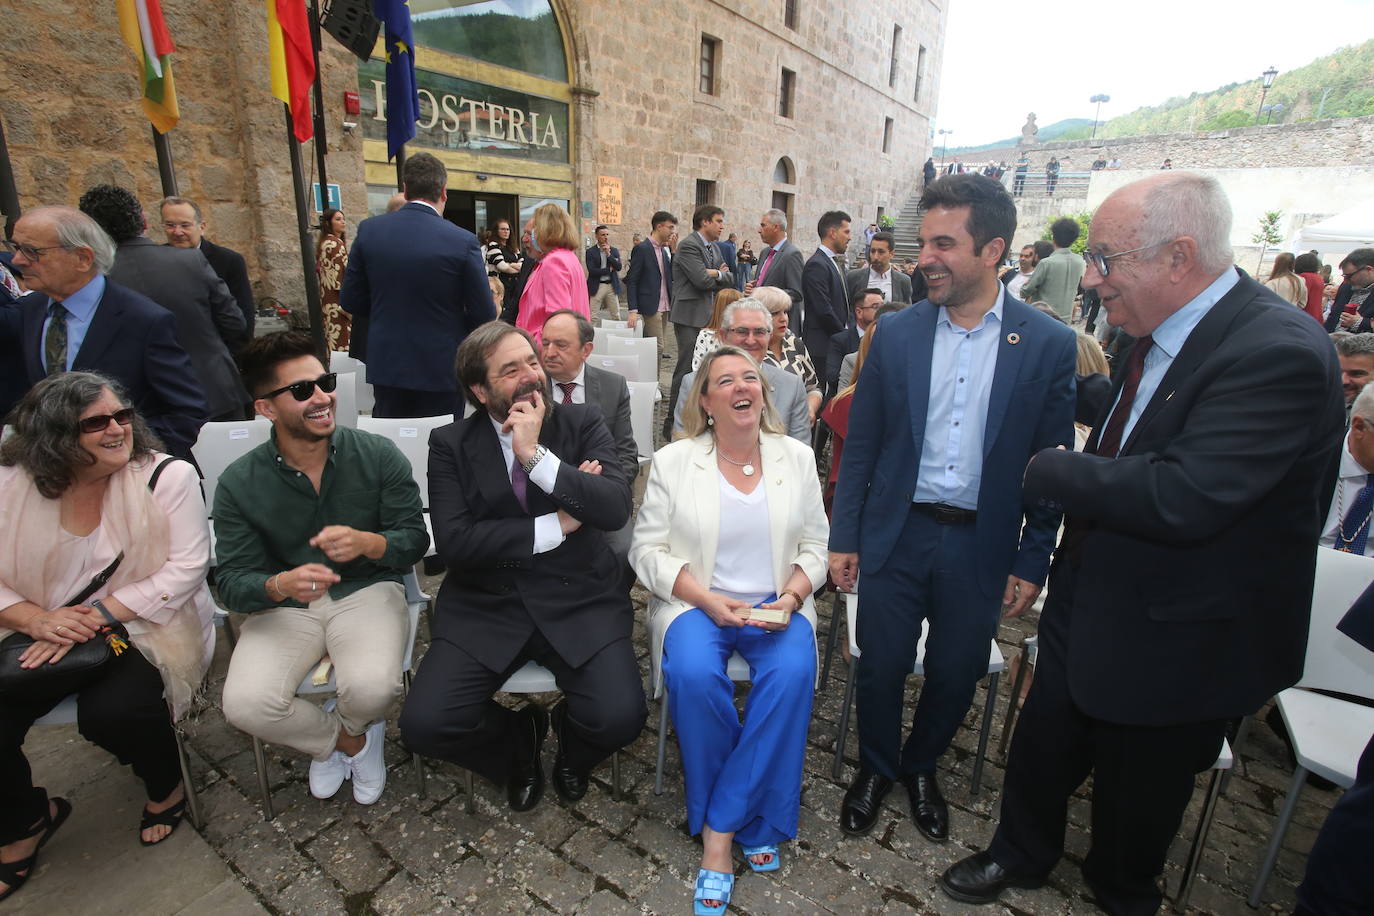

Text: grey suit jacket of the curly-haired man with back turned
xmin=109 ymin=239 xmax=253 ymax=416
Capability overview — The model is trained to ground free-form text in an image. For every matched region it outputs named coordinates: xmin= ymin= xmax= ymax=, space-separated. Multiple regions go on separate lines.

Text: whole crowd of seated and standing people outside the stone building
xmin=0 ymin=161 xmax=1374 ymax=915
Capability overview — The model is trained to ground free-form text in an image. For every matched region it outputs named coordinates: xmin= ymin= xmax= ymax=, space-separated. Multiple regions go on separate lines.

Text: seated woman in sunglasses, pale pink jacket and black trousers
xmin=0 ymin=372 xmax=214 ymax=900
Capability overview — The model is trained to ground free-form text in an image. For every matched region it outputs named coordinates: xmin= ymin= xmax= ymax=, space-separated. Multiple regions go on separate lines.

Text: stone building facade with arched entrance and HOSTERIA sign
xmin=0 ymin=0 xmax=945 ymax=306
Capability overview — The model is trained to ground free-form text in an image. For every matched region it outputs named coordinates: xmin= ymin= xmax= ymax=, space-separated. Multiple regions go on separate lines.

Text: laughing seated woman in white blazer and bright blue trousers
xmin=629 ymin=346 xmax=830 ymax=915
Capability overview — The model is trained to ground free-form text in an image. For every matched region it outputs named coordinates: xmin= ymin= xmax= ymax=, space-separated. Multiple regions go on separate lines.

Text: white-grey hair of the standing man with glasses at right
xmin=1140 ymin=172 xmax=1235 ymax=273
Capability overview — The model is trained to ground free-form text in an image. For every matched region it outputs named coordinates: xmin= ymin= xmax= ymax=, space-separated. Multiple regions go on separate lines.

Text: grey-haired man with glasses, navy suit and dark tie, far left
xmin=0 ymin=206 xmax=206 ymax=457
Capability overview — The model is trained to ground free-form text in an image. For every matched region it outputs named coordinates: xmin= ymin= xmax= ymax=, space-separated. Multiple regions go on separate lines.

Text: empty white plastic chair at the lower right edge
xmin=1249 ymin=548 xmax=1374 ymax=906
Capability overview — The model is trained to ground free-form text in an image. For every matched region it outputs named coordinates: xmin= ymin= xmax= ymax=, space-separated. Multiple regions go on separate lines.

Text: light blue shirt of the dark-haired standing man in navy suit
xmin=912 ymin=290 xmax=1006 ymax=509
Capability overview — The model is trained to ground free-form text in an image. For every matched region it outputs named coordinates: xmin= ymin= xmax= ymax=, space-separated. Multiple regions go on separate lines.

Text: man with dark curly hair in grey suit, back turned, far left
xmin=81 ymin=184 xmax=253 ymax=420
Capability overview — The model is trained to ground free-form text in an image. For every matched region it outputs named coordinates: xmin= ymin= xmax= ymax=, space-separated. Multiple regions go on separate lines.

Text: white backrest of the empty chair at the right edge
xmin=1297 ymin=547 xmax=1374 ymax=699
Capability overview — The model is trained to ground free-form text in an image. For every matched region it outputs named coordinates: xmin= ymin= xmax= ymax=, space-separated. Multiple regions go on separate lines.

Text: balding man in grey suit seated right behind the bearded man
xmin=540 ymin=309 xmax=639 ymax=592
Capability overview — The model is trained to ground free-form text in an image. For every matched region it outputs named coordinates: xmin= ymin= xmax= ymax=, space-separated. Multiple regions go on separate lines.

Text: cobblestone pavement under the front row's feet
xmin=163 ymin=580 xmax=1337 ymax=916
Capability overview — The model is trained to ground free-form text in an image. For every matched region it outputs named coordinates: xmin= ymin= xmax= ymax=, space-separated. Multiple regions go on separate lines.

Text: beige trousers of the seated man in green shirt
xmin=224 ymin=582 xmax=409 ymax=761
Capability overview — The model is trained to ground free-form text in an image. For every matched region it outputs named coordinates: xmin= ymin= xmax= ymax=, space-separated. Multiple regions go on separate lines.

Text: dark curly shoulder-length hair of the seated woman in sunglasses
xmin=0 ymin=372 xmax=162 ymax=500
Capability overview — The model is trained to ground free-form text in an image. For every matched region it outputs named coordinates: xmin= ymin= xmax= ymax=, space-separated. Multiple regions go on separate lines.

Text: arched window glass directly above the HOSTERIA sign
xmin=411 ymin=0 xmax=567 ymax=82
